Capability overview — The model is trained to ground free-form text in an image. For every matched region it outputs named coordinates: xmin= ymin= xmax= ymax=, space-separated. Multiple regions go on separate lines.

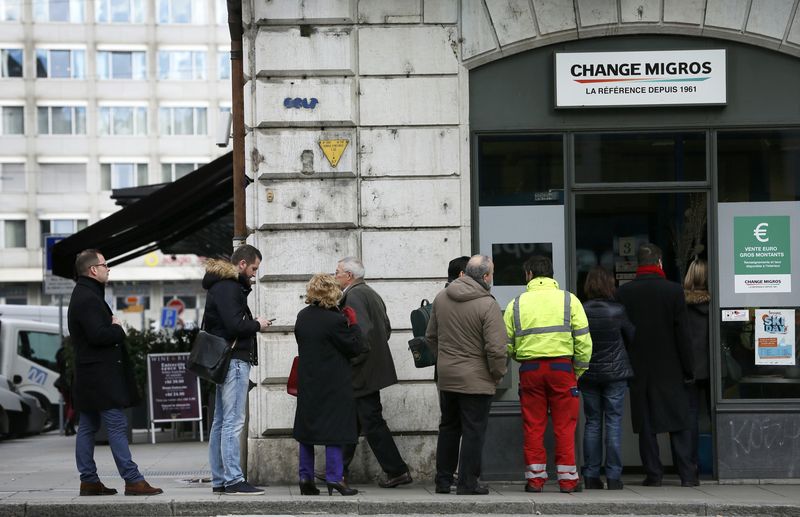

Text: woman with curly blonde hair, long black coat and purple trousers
xmin=293 ymin=274 xmax=363 ymax=495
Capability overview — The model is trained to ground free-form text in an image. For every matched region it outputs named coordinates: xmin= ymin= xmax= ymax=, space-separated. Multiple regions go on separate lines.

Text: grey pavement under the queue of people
xmin=0 ymin=432 xmax=800 ymax=517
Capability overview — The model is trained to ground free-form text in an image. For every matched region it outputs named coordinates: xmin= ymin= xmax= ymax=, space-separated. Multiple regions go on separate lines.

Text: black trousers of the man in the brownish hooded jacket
xmin=436 ymin=391 xmax=492 ymax=489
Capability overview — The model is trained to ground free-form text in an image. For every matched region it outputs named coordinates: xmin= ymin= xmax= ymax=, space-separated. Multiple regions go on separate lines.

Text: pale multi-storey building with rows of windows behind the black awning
xmin=0 ymin=0 xmax=231 ymax=322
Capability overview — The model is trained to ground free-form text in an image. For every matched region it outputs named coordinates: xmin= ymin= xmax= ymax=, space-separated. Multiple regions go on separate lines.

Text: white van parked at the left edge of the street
xmin=0 ymin=317 xmax=62 ymax=423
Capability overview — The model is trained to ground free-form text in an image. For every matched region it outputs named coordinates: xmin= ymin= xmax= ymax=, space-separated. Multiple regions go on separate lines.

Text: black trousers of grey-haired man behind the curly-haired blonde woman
xmin=342 ymin=391 xmax=408 ymax=478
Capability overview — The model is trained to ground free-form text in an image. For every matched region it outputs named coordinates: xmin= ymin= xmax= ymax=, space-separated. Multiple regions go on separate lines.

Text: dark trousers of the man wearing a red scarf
xmin=639 ymin=402 xmax=697 ymax=481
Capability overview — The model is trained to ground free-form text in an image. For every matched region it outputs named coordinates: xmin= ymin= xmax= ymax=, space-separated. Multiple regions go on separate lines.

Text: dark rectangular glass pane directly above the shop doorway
xmin=575 ymin=132 xmax=706 ymax=183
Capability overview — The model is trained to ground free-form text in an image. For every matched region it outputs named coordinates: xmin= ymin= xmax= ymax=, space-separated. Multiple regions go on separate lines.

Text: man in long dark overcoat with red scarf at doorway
xmin=617 ymin=243 xmax=698 ymax=487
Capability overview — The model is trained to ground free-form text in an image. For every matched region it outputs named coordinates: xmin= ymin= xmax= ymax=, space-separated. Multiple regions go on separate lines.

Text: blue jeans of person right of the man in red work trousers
xmin=581 ymin=381 xmax=628 ymax=479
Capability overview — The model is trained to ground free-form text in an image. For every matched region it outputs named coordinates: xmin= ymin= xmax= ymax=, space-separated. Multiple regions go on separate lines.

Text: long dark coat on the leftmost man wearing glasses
xmin=67 ymin=276 xmax=139 ymax=411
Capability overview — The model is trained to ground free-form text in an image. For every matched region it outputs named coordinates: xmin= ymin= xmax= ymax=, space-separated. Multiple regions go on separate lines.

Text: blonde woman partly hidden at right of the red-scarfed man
xmin=683 ymin=258 xmax=711 ymax=480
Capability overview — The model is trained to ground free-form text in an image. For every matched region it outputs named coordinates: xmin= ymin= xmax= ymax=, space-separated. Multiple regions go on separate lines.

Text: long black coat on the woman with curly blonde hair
xmin=292 ymin=305 xmax=363 ymax=445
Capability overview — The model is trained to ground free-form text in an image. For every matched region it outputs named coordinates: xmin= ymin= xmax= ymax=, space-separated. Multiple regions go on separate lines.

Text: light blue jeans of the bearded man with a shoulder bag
xmin=208 ymin=359 xmax=250 ymax=487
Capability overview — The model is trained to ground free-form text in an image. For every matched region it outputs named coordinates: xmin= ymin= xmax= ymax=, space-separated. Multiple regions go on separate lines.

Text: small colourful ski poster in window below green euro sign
xmin=755 ymin=309 xmax=795 ymax=366
